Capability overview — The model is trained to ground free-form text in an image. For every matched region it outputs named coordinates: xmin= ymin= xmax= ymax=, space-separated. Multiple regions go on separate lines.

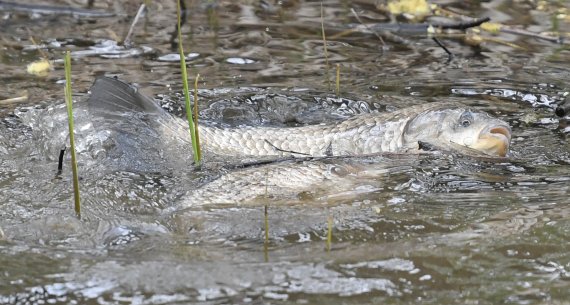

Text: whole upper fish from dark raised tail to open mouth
xmin=88 ymin=77 xmax=511 ymax=157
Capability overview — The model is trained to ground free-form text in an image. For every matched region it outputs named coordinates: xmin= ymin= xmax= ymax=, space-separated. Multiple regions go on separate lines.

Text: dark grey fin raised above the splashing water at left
xmin=87 ymin=76 xmax=165 ymax=116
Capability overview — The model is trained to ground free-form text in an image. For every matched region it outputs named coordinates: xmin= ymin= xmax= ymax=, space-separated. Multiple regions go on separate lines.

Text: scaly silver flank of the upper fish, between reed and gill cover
xmin=196 ymin=104 xmax=422 ymax=156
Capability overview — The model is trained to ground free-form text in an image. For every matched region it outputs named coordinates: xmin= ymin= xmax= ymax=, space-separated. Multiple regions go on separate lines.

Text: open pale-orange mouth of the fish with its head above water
xmin=472 ymin=126 xmax=511 ymax=157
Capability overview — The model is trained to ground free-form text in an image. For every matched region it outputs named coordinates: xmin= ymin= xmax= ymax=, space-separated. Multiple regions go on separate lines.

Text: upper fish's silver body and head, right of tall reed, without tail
xmin=196 ymin=103 xmax=511 ymax=156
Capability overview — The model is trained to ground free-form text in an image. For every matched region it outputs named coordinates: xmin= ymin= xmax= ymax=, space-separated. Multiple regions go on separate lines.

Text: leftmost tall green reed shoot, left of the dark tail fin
xmin=64 ymin=51 xmax=81 ymax=217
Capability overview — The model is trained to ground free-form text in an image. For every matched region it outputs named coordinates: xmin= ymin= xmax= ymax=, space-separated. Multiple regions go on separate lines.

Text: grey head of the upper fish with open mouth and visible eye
xmin=410 ymin=108 xmax=511 ymax=157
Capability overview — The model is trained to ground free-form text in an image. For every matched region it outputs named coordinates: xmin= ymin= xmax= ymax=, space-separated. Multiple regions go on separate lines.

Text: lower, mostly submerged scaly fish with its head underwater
xmin=175 ymin=156 xmax=408 ymax=204
